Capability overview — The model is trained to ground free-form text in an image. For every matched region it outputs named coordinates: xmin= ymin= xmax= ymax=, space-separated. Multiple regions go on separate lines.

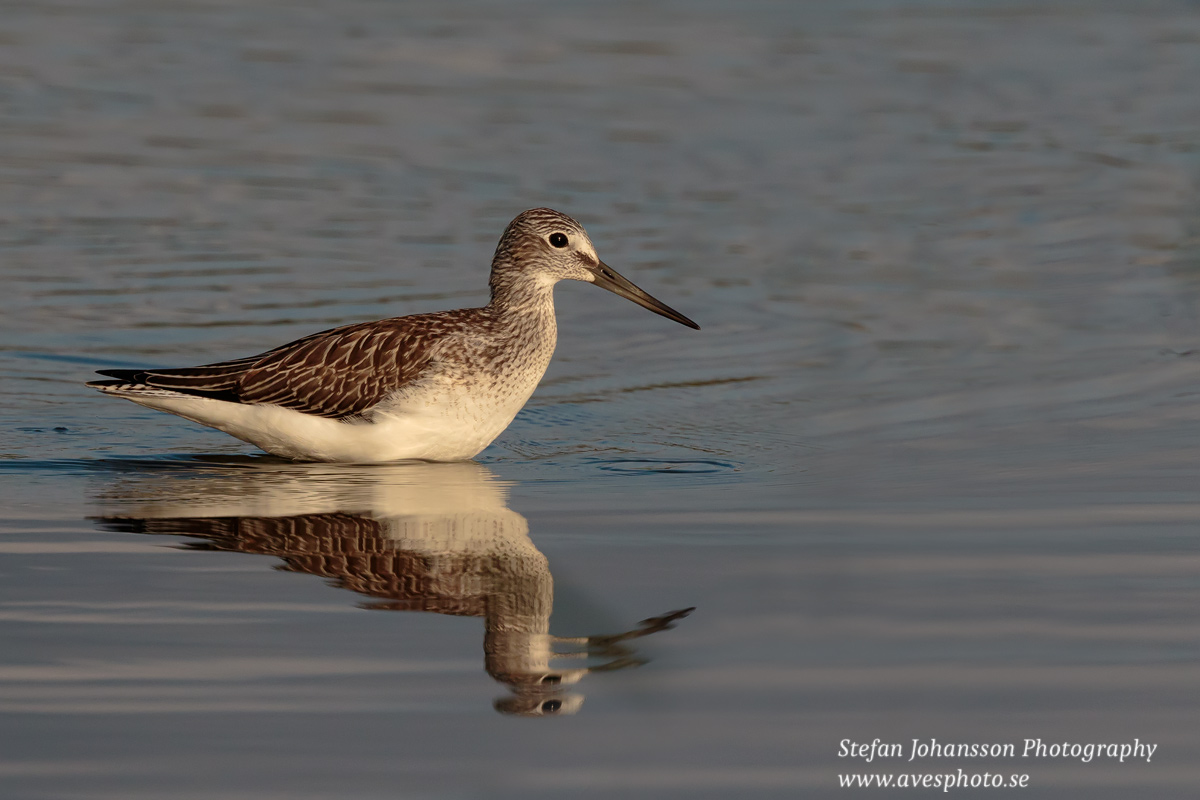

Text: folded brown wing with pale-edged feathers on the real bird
xmin=100 ymin=309 xmax=475 ymax=419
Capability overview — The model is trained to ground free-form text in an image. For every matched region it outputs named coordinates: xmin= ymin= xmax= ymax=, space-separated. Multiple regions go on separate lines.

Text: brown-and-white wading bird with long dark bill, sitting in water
xmin=88 ymin=209 xmax=700 ymax=462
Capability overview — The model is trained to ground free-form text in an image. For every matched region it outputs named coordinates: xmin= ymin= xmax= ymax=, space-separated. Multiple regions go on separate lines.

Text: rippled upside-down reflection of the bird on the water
xmin=88 ymin=459 xmax=691 ymax=716
